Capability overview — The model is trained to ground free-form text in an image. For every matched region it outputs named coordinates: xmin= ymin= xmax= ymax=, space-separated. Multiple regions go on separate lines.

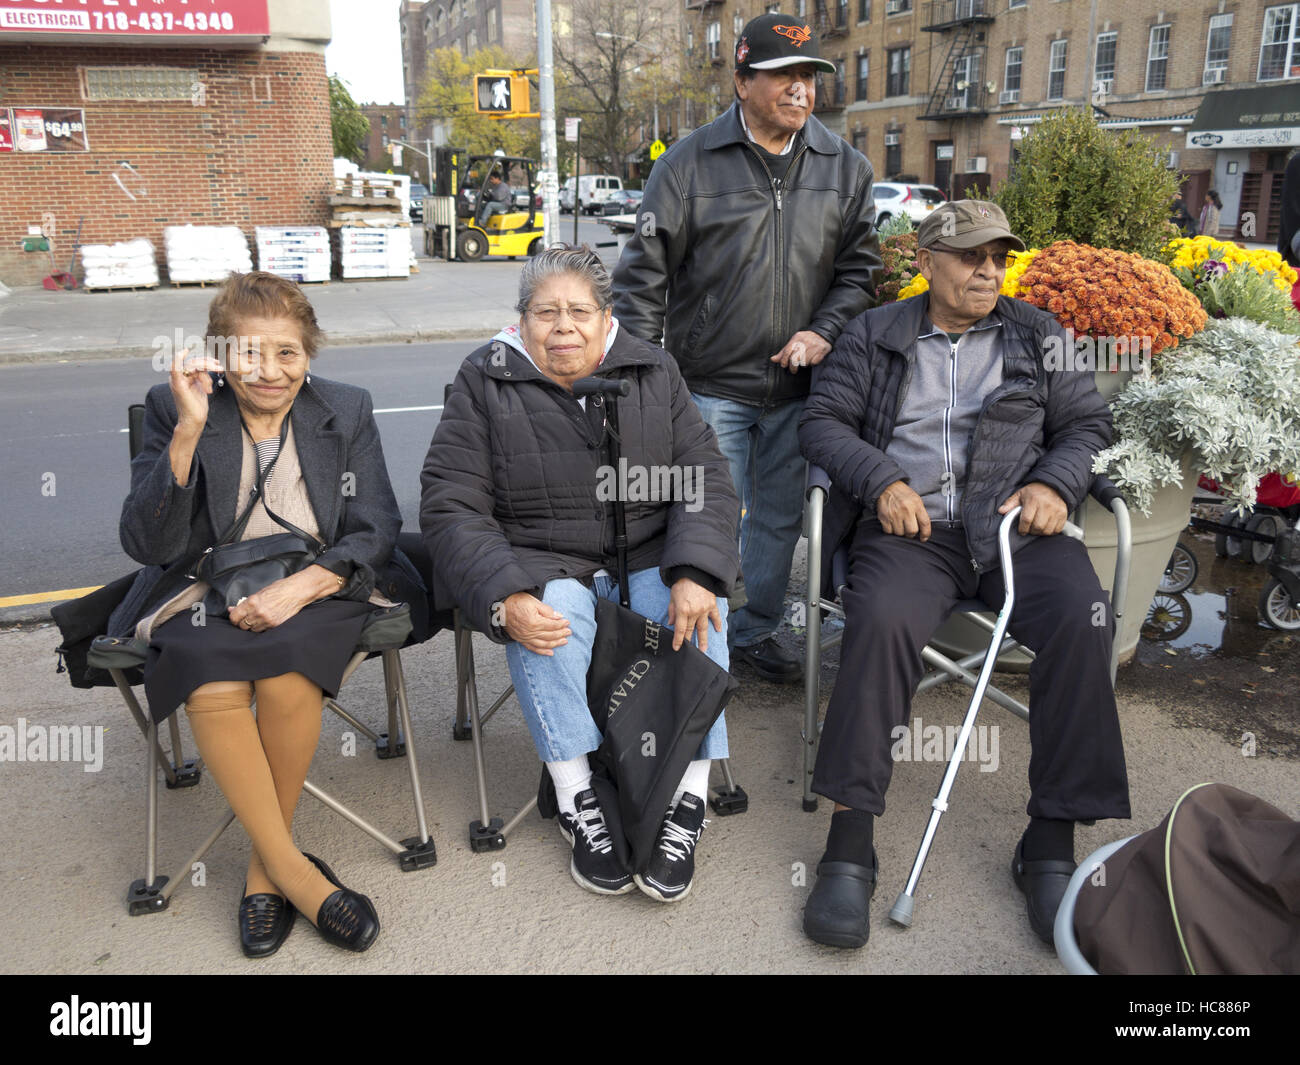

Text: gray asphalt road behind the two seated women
xmin=0 ymin=338 xmax=475 ymax=608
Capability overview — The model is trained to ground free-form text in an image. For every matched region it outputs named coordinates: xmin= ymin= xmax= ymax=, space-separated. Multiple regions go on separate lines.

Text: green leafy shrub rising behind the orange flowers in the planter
xmin=992 ymin=108 xmax=1179 ymax=259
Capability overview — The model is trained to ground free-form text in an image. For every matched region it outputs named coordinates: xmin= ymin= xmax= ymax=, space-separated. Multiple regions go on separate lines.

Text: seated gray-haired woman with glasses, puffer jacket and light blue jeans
xmin=420 ymin=247 xmax=738 ymax=902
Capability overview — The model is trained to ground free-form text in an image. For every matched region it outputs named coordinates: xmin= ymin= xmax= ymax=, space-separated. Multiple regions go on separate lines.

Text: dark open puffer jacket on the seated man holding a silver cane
xmin=800 ymin=296 xmax=1112 ymax=587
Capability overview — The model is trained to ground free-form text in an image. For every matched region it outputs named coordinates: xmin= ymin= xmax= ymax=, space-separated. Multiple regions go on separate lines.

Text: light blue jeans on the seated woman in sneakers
xmin=506 ymin=570 xmax=728 ymax=762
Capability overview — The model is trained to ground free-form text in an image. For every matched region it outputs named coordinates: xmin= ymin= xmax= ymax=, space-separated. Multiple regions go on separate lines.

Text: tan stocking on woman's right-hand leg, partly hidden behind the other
xmin=247 ymin=674 xmax=322 ymax=895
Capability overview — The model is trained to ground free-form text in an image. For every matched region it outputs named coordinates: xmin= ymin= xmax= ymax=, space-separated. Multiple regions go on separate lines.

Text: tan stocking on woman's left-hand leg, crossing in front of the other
xmin=186 ymin=681 xmax=334 ymax=923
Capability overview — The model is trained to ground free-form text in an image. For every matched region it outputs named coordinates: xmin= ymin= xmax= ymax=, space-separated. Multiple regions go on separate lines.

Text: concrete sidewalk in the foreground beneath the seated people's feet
xmin=0 ymin=546 xmax=1300 ymax=975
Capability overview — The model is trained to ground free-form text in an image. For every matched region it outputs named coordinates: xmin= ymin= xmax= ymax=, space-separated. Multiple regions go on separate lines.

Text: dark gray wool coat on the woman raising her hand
xmin=108 ymin=375 xmax=402 ymax=636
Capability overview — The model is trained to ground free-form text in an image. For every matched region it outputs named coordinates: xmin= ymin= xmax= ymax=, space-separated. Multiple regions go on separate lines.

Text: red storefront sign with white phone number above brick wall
xmin=0 ymin=0 xmax=270 ymax=39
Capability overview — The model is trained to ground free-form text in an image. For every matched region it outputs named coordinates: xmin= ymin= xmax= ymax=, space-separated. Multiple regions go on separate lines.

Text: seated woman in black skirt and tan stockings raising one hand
xmin=109 ymin=273 xmax=402 ymax=957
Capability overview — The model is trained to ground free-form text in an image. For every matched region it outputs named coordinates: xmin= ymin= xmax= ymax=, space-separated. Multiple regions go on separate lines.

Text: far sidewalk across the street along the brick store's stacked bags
xmin=0 ymin=259 xmax=523 ymax=363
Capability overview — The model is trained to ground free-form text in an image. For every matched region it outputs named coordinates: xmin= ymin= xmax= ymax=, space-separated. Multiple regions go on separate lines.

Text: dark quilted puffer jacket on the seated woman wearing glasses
xmin=420 ymin=329 xmax=740 ymax=642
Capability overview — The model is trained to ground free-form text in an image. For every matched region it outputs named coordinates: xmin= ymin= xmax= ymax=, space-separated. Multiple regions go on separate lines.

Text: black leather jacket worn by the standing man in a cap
xmin=614 ymin=101 xmax=880 ymax=403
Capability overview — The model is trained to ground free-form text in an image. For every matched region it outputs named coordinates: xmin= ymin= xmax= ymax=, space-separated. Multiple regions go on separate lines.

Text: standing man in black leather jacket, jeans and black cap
xmin=614 ymin=14 xmax=880 ymax=683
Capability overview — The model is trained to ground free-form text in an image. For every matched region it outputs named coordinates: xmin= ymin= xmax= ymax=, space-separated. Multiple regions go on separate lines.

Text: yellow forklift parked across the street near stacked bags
xmin=424 ymin=148 xmax=543 ymax=263
